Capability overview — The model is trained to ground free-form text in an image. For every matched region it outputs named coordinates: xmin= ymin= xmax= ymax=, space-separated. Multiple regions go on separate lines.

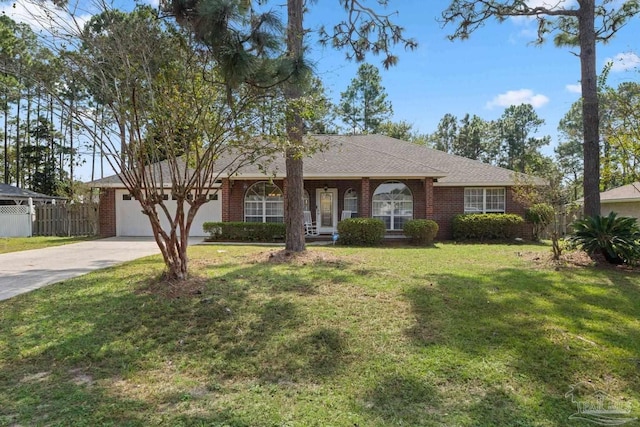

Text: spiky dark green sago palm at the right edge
xmin=567 ymin=212 xmax=640 ymax=264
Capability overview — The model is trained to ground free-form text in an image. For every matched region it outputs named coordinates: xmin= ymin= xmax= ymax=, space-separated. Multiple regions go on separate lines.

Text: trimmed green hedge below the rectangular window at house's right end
xmin=451 ymin=214 xmax=524 ymax=240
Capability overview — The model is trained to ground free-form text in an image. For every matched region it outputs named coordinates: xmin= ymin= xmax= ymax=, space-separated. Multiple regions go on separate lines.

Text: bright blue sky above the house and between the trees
xmin=0 ymin=0 xmax=640 ymax=179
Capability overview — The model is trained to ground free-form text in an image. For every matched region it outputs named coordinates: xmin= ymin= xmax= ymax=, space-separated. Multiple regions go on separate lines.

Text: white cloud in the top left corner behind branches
xmin=0 ymin=0 xmax=91 ymax=33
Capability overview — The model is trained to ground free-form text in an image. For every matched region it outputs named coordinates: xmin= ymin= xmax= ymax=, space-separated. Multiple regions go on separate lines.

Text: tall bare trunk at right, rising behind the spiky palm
xmin=578 ymin=0 xmax=600 ymax=216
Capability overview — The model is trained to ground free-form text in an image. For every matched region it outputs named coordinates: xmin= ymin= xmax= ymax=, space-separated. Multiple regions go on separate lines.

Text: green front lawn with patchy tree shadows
xmin=0 ymin=244 xmax=640 ymax=427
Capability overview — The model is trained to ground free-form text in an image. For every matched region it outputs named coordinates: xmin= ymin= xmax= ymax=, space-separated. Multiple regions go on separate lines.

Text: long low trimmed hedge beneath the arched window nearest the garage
xmin=202 ymin=222 xmax=285 ymax=242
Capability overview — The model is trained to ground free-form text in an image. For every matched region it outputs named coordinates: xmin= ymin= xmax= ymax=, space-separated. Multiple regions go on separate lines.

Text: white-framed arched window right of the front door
xmin=371 ymin=182 xmax=413 ymax=230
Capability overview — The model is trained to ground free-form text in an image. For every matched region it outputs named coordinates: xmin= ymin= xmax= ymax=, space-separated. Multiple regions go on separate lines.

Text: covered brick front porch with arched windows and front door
xmin=222 ymin=177 xmax=434 ymax=238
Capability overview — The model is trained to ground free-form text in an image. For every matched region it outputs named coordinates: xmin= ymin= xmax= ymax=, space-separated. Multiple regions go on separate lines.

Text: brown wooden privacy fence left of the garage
xmin=33 ymin=203 xmax=98 ymax=236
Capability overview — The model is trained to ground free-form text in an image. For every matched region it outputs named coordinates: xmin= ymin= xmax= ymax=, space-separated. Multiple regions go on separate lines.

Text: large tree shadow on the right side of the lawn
xmin=405 ymin=269 xmax=640 ymax=425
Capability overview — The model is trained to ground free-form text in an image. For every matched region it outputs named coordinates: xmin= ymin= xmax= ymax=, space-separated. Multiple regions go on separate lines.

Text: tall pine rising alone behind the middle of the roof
xmin=338 ymin=64 xmax=393 ymax=134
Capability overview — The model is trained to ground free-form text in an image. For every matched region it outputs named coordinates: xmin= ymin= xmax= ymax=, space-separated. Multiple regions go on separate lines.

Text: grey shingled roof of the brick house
xmin=90 ymin=135 xmax=544 ymax=187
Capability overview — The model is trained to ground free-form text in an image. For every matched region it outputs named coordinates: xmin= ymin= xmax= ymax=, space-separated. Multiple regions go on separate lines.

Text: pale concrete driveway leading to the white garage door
xmin=0 ymin=237 xmax=202 ymax=300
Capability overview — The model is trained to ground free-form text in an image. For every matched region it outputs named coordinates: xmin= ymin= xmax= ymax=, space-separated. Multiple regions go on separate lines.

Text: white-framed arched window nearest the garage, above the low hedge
xmin=244 ymin=181 xmax=284 ymax=222
